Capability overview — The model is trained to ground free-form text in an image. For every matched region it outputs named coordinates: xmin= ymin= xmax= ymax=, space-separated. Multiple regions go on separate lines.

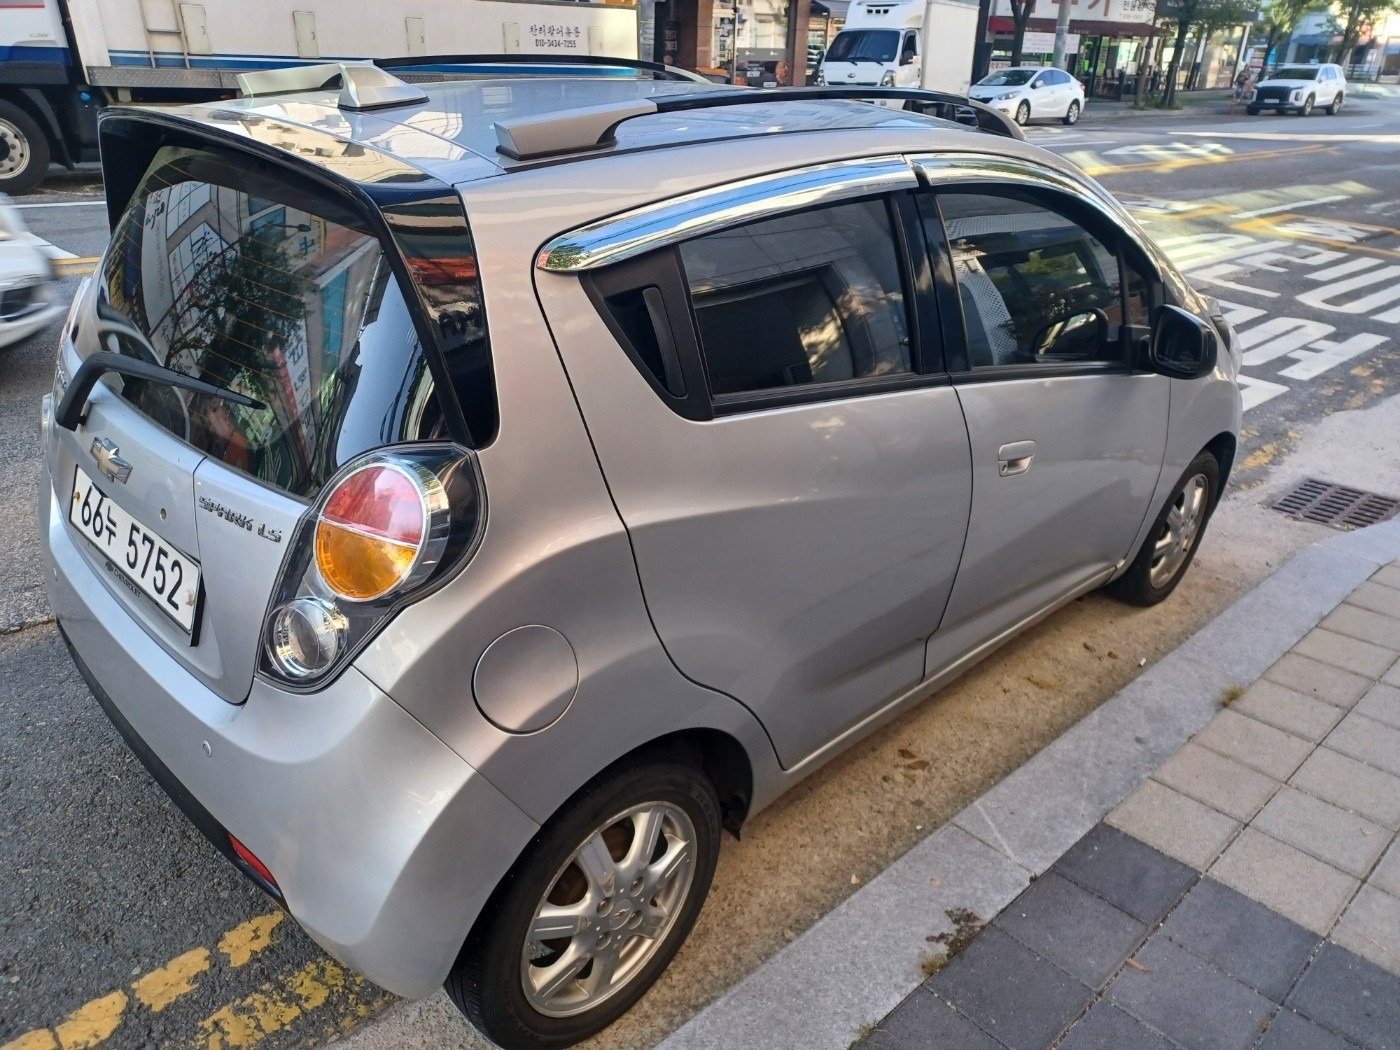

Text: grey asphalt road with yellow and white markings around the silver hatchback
xmin=0 ymin=88 xmax=1400 ymax=1050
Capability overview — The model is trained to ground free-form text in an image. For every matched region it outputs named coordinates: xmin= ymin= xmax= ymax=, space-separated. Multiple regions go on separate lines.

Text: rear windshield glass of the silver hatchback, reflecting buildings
xmin=93 ymin=147 xmax=445 ymax=497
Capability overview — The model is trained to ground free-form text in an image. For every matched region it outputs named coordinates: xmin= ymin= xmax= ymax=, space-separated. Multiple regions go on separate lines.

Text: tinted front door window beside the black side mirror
xmin=930 ymin=193 xmax=1123 ymax=368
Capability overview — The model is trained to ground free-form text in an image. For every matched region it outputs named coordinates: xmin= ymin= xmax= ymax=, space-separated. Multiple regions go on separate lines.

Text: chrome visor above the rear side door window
xmin=536 ymin=157 xmax=918 ymax=273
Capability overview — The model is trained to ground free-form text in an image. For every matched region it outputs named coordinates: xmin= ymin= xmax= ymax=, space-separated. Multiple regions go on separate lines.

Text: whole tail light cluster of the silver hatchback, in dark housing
xmin=260 ymin=445 xmax=484 ymax=687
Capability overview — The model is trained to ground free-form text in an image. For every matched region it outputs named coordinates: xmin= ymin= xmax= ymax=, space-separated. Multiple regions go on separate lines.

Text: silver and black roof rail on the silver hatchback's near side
xmin=496 ymin=87 xmax=1026 ymax=161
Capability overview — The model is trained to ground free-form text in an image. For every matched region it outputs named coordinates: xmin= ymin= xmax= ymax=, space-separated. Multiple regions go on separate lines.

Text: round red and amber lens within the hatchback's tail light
xmin=315 ymin=465 xmax=427 ymax=602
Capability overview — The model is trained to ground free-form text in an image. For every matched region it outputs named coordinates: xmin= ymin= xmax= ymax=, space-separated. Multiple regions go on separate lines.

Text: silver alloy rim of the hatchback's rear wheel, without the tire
xmin=521 ymin=802 xmax=696 ymax=1018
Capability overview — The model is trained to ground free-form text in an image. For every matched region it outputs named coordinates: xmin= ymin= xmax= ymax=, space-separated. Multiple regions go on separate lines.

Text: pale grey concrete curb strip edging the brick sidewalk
xmin=661 ymin=519 xmax=1400 ymax=1050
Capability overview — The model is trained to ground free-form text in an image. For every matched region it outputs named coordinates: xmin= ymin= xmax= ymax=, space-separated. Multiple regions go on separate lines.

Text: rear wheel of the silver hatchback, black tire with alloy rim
xmin=445 ymin=752 xmax=720 ymax=1050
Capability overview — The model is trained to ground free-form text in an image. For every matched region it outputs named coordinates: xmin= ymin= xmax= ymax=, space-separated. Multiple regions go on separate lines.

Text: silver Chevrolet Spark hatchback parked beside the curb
xmin=41 ymin=59 xmax=1240 ymax=1047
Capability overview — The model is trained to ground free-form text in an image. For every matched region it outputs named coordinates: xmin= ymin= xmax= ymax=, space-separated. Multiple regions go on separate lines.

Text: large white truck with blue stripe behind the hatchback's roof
xmin=0 ymin=0 xmax=637 ymax=193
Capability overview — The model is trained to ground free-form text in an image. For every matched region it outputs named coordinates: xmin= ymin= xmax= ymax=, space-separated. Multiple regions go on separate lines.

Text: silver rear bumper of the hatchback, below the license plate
xmin=39 ymin=472 xmax=538 ymax=997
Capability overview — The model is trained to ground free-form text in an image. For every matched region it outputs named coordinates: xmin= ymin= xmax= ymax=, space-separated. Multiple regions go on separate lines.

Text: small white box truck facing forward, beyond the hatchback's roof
xmin=816 ymin=0 xmax=977 ymax=95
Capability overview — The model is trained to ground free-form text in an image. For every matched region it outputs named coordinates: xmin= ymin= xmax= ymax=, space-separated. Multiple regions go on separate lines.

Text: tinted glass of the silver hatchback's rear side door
xmin=680 ymin=200 xmax=910 ymax=396
